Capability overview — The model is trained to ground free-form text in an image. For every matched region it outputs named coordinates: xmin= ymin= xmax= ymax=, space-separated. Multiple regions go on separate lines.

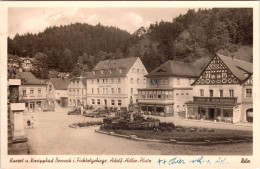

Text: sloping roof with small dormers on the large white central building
xmin=87 ymin=57 xmax=138 ymax=79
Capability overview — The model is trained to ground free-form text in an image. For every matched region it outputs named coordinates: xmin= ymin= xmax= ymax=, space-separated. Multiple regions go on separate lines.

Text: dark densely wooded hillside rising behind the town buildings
xmin=8 ymin=8 xmax=253 ymax=76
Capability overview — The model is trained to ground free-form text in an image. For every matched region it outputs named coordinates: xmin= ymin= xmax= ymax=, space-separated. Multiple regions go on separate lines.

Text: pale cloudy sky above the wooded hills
xmin=8 ymin=7 xmax=192 ymax=38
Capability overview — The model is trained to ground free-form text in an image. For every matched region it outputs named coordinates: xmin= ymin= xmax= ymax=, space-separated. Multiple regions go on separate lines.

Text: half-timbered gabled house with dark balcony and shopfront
xmin=186 ymin=54 xmax=253 ymax=123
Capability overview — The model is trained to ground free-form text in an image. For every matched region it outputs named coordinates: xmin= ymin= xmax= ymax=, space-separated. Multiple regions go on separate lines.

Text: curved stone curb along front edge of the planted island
xmin=95 ymin=130 xmax=253 ymax=145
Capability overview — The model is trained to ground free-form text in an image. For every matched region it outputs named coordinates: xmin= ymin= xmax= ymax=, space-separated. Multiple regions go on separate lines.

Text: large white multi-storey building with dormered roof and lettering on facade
xmin=87 ymin=57 xmax=147 ymax=108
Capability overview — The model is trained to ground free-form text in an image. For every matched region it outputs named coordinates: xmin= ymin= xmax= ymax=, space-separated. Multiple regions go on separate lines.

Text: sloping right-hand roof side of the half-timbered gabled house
xmin=217 ymin=54 xmax=253 ymax=82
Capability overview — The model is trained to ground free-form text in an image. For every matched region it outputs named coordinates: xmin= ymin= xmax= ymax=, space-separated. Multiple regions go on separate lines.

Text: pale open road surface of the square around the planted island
xmin=24 ymin=108 xmax=253 ymax=155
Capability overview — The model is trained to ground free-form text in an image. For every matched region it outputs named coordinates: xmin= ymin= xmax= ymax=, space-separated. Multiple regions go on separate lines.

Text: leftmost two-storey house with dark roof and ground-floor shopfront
xmin=16 ymin=72 xmax=46 ymax=112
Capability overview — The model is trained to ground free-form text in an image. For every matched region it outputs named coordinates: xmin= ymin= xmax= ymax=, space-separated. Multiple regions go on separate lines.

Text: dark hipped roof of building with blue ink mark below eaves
xmin=146 ymin=60 xmax=200 ymax=77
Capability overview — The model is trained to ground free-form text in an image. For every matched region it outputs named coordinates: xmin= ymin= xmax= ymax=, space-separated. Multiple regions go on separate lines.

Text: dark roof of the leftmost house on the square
xmin=16 ymin=72 xmax=46 ymax=85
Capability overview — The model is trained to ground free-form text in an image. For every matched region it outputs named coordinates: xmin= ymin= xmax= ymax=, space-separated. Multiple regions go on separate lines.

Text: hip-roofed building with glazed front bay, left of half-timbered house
xmin=138 ymin=60 xmax=199 ymax=116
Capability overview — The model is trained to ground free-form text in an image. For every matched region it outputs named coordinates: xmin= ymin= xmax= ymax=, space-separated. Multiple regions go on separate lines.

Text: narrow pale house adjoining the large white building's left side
xmin=68 ymin=72 xmax=89 ymax=108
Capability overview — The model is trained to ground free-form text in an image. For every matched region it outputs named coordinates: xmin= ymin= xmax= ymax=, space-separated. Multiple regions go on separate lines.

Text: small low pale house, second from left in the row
xmin=47 ymin=78 xmax=70 ymax=107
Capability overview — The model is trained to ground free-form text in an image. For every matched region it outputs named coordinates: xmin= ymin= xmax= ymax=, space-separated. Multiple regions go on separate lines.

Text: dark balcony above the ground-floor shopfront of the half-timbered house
xmin=193 ymin=97 xmax=237 ymax=105
